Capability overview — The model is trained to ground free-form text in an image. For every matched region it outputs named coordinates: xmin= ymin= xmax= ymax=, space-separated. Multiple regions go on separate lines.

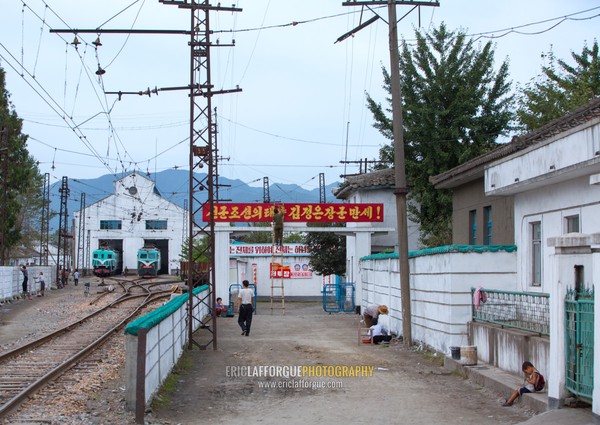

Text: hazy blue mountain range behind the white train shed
xmin=50 ymin=170 xmax=339 ymax=232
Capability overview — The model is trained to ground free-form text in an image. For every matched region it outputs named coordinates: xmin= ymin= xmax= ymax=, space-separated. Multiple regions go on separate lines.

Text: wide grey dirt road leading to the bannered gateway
xmin=146 ymin=303 xmax=531 ymax=425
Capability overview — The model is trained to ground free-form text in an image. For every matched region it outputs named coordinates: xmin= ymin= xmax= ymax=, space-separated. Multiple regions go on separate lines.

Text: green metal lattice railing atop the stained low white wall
xmin=471 ymin=288 xmax=550 ymax=335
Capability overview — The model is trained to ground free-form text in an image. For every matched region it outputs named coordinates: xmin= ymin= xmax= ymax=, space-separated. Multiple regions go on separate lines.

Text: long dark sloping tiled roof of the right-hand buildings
xmin=429 ymin=98 xmax=600 ymax=188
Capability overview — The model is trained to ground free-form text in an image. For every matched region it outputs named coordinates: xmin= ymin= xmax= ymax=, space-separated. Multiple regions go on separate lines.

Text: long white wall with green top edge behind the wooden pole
xmin=359 ymin=251 xmax=516 ymax=353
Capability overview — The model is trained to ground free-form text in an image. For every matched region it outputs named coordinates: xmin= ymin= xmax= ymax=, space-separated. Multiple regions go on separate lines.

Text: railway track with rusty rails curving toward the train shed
xmin=0 ymin=279 xmax=176 ymax=423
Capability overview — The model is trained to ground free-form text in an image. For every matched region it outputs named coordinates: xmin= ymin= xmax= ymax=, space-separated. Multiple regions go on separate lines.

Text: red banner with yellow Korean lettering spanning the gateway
xmin=202 ymin=203 xmax=383 ymax=223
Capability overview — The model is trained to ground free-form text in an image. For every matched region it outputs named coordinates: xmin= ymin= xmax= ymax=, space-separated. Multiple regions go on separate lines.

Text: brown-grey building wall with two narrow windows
xmin=452 ymin=177 xmax=515 ymax=245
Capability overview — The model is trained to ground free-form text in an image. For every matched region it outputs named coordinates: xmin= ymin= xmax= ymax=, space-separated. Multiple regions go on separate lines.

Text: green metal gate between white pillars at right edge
xmin=565 ymin=289 xmax=594 ymax=401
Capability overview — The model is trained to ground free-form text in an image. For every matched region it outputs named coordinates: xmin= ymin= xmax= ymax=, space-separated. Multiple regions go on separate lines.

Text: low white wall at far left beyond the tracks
xmin=0 ymin=266 xmax=56 ymax=303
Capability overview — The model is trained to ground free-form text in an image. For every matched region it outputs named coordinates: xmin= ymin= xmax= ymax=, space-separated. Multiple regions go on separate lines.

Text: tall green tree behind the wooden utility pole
xmin=367 ymin=23 xmax=513 ymax=247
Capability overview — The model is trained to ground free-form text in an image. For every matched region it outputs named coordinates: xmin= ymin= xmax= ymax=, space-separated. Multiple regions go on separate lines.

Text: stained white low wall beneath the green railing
xmin=469 ymin=322 xmax=550 ymax=376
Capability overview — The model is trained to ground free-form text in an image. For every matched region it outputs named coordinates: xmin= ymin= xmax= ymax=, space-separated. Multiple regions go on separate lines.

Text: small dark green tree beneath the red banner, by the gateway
xmin=304 ymin=223 xmax=346 ymax=276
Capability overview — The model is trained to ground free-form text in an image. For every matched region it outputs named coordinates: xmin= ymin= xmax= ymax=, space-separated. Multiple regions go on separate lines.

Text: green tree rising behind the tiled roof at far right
xmin=517 ymin=40 xmax=600 ymax=131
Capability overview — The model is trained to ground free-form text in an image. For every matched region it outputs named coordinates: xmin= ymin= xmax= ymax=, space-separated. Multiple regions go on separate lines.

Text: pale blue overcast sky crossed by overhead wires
xmin=0 ymin=0 xmax=600 ymax=192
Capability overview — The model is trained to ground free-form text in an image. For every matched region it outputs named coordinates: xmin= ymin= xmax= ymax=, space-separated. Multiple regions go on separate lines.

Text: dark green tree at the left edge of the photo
xmin=0 ymin=67 xmax=43 ymax=259
